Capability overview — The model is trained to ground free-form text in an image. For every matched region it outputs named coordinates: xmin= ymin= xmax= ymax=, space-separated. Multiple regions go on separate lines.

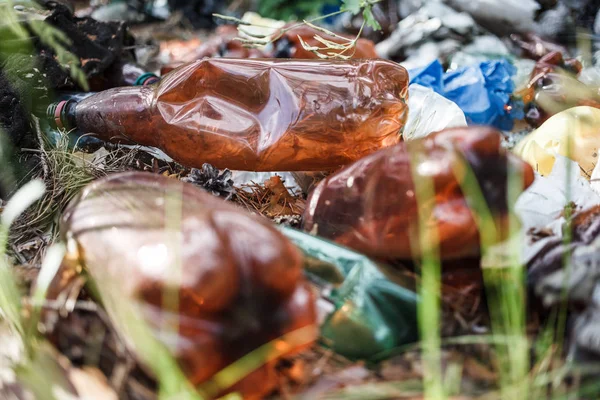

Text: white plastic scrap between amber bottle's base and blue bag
xmin=402 ymin=83 xmax=467 ymax=140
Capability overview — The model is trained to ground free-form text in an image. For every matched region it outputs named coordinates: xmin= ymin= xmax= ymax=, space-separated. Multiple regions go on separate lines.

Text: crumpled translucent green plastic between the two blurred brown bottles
xmin=280 ymin=227 xmax=419 ymax=359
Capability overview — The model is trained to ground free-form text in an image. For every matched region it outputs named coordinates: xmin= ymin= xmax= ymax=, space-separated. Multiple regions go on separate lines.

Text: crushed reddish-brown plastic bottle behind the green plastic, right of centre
xmin=303 ymin=127 xmax=533 ymax=259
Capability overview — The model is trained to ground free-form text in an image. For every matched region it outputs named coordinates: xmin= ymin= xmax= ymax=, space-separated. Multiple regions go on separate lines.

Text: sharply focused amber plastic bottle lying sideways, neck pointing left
xmin=49 ymin=59 xmax=408 ymax=171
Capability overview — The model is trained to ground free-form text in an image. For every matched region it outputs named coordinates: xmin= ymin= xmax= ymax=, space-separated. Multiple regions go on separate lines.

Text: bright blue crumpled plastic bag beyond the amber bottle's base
xmin=409 ymin=59 xmax=523 ymax=130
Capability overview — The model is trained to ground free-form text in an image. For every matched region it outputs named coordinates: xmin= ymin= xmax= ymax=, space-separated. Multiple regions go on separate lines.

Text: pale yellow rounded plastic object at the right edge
xmin=514 ymin=106 xmax=600 ymax=179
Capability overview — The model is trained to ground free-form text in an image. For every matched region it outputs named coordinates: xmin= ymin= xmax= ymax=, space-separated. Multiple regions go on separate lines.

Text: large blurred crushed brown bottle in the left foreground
xmin=61 ymin=172 xmax=317 ymax=398
